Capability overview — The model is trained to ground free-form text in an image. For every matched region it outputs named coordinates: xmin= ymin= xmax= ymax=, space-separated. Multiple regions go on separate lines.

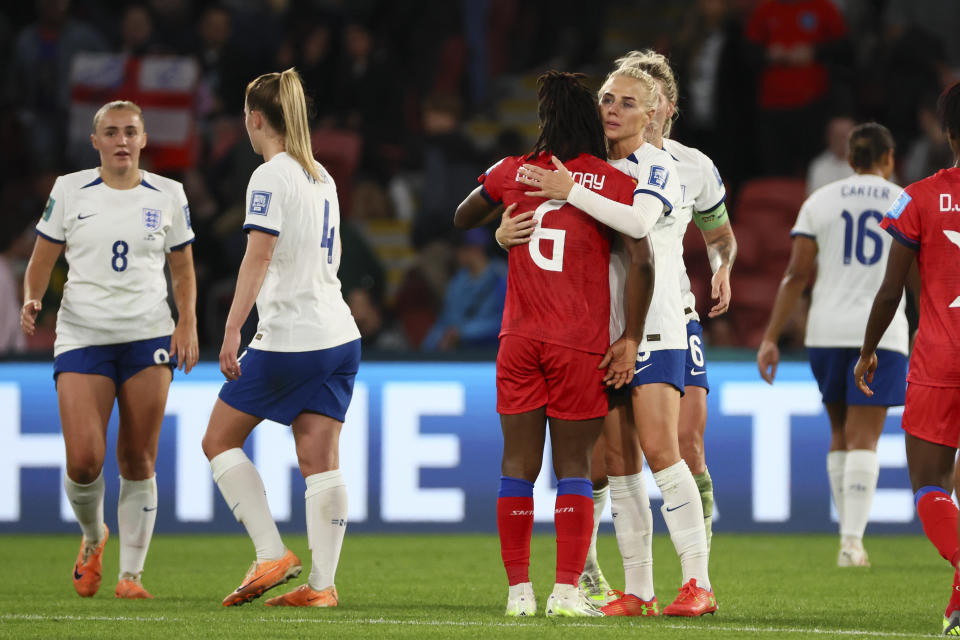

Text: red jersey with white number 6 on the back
xmin=479 ymin=154 xmax=635 ymax=353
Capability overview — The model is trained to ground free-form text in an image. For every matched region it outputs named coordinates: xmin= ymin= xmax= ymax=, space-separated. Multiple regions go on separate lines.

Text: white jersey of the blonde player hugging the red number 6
xmin=610 ymin=142 xmax=687 ymax=351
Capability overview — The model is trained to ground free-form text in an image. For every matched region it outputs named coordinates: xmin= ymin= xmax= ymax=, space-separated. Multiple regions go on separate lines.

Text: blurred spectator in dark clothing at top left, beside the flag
xmin=6 ymin=0 xmax=107 ymax=170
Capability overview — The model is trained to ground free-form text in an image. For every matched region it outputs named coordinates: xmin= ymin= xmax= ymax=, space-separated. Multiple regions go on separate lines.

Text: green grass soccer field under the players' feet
xmin=0 ymin=533 xmax=952 ymax=640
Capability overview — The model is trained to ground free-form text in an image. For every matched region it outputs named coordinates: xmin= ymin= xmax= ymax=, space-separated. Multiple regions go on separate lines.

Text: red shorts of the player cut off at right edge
xmin=900 ymin=382 xmax=960 ymax=448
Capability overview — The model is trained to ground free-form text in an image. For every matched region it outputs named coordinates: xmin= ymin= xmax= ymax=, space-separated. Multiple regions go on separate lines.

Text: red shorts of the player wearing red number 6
xmin=497 ymin=335 xmax=607 ymax=420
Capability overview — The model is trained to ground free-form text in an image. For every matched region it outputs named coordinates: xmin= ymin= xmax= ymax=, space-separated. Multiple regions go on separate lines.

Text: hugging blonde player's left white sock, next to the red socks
xmin=609 ymin=473 xmax=656 ymax=600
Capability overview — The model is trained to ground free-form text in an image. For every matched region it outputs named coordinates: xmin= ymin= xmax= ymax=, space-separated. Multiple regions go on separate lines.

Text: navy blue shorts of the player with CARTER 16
xmin=807 ymin=347 xmax=907 ymax=407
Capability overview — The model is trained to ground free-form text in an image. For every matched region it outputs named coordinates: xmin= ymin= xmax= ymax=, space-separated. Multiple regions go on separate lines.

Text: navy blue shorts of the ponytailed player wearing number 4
xmin=220 ymin=340 xmax=360 ymax=425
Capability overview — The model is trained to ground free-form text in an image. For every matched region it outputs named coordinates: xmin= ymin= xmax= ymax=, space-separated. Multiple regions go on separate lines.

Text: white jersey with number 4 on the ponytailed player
xmin=243 ymin=153 xmax=360 ymax=352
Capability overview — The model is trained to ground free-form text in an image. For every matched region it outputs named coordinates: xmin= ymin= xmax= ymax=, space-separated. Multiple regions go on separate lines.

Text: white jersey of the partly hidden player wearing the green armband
xmin=663 ymin=138 xmax=727 ymax=321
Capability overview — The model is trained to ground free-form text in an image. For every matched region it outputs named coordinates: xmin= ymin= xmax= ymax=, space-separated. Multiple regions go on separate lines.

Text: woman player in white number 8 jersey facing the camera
xmin=21 ymin=101 xmax=197 ymax=599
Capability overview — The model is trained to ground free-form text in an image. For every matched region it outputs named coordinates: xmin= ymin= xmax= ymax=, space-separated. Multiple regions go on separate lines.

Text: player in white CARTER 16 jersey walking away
xmin=757 ymin=123 xmax=907 ymax=567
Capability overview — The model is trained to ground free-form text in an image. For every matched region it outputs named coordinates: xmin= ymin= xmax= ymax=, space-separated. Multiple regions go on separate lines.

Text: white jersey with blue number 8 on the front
xmin=37 ymin=169 xmax=193 ymax=356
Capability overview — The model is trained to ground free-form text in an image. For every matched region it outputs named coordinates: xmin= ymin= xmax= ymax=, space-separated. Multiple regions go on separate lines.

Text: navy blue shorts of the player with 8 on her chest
xmin=53 ymin=336 xmax=177 ymax=388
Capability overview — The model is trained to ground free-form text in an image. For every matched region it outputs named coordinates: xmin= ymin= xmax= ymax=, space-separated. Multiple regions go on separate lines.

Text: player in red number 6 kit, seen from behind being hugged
xmin=454 ymin=71 xmax=652 ymax=616
